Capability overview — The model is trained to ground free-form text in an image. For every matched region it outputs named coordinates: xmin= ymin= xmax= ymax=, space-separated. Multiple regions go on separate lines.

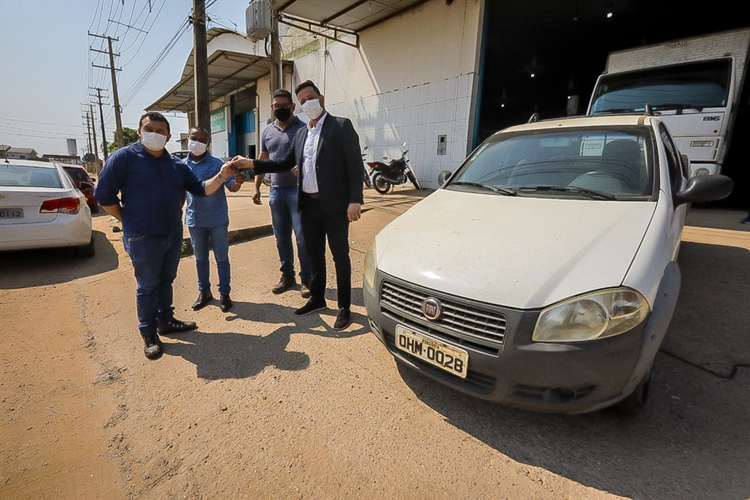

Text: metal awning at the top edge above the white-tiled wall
xmin=271 ymin=0 xmax=427 ymax=32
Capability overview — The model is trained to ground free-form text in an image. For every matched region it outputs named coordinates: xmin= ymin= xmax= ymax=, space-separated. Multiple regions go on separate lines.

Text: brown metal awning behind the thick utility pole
xmin=146 ymin=28 xmax=291 ymax=113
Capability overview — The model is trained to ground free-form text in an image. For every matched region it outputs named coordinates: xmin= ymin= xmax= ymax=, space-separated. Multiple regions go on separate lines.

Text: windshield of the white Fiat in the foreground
xmin=446 ymin=126 xmax=653 ymax=200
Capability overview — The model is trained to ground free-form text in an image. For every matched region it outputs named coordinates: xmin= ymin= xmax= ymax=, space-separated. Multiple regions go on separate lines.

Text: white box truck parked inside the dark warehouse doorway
xmin=587 ymin=28 xmax=750 ymax=176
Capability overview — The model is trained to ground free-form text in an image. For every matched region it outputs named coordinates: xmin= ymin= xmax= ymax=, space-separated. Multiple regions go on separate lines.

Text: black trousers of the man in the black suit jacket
xmin=301 ymin=195 xmax=352 ymax=308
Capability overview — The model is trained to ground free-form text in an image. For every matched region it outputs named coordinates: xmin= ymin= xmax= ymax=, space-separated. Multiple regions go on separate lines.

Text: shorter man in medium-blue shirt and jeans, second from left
xmin=183 ymin=127 xmax=244 ymax=312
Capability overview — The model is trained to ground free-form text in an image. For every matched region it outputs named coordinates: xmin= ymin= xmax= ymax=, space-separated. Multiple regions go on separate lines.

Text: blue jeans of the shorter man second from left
xmin=188 ymin=224 xmax=230 ymax=295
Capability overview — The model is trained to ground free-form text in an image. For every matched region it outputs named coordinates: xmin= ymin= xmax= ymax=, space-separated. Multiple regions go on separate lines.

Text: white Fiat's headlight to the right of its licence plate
xmin=531 ymin=288 xmax=651 ymax=342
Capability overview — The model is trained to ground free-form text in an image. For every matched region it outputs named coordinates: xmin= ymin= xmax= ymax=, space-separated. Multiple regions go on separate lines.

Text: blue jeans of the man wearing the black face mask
xmin=268 ymin=186 xmax=312 ymax=283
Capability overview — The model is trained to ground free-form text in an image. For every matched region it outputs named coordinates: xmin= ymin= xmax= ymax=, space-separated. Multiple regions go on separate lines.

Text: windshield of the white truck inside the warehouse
xmin=589 ymin=59 xmax=731 ymax=115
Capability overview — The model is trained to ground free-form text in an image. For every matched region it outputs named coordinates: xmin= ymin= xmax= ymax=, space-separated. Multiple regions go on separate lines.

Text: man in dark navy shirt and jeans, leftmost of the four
xmin=95 ymin=112 xmax=232 ymax=359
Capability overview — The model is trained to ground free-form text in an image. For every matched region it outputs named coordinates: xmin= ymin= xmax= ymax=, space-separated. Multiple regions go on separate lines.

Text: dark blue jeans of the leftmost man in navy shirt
xmin=122 ymin=231 xmax=182 ymax=337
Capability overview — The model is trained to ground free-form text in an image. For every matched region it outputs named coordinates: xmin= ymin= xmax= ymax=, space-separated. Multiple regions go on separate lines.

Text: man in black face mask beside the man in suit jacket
xmin=253 ymin=89 xmax=312 ymax=298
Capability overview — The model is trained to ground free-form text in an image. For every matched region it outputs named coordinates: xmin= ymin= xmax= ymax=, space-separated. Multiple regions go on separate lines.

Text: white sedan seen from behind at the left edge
xmin=0 ymin=160 xmax=94 ymax=257
